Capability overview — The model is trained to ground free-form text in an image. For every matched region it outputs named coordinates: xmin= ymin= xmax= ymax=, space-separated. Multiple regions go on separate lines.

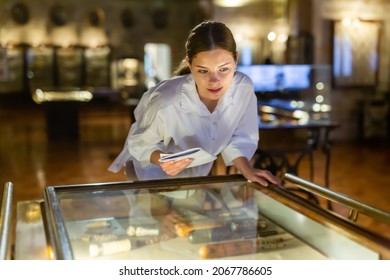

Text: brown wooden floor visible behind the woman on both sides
xmin=0 ymin=99 xmax=390 ymax=242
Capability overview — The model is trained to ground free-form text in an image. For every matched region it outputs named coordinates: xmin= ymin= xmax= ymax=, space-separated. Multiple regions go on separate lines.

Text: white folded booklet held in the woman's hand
xmin=160 ymin=148 xmax=217 ymax=168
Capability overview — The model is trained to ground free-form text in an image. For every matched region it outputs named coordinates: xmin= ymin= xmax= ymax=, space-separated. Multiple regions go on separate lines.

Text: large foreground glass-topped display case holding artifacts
xmin=42 ymin=174 xmax=390 ymax=260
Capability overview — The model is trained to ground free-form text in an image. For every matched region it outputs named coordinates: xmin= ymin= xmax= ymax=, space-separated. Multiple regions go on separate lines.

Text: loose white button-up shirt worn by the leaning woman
xmin=109 ymin=72 xmax=259 ymax=180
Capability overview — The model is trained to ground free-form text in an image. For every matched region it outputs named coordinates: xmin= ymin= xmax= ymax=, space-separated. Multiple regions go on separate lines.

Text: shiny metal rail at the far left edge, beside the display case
xmin=0 ymin=182 xmax=14 ymax=260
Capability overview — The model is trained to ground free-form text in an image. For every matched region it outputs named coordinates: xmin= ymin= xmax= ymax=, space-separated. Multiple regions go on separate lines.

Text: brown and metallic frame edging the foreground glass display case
xmin=43 ymin=174 xmax=390 ymax=259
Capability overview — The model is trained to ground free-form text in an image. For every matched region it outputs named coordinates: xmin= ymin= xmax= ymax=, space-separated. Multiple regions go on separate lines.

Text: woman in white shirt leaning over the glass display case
xmin=109 ymin=21 xmax=279 ymax=186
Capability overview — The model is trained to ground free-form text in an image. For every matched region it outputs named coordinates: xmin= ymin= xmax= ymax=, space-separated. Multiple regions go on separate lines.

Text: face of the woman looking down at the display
xmin=190 ymin=49 xmax=237 ymax=103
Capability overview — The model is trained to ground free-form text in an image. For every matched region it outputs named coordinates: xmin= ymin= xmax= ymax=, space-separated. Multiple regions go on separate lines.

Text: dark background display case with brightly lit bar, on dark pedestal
xmin=27 ymin=46 xmax=92 ymax=141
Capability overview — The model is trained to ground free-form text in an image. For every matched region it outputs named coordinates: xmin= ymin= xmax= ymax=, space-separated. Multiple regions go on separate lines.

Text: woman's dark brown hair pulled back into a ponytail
xmin=174 ymin=20 xmax=237 ymax=76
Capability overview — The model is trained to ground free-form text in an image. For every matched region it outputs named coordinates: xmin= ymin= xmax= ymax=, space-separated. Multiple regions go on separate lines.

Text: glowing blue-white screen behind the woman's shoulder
xmin=237 ymin=64 xmax=311 ymax=92
